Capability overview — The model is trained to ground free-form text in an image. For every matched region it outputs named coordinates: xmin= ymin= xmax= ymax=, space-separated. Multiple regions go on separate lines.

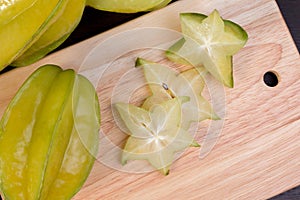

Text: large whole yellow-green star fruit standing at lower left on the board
xmin=0 ymin=65 xmax=100 ymax=200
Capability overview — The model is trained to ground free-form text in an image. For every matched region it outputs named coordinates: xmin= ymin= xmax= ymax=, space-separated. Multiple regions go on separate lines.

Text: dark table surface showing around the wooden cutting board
xmin=0 ymin=0 xmax=300 ymax=200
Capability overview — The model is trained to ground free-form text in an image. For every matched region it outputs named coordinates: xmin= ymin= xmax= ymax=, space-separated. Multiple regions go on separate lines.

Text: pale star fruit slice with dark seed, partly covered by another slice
xmin=136 ymin=58 xmax=219 ymax=129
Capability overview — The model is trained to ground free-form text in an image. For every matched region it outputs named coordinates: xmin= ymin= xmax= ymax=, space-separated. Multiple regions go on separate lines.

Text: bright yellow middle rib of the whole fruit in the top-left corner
xmin=0 ymin=0 xmax=67 ymax=70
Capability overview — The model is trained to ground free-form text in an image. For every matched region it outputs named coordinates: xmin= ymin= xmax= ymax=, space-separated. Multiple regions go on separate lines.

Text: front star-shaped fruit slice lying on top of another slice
xmin=115 ymin=98 xmax=199 ymax=175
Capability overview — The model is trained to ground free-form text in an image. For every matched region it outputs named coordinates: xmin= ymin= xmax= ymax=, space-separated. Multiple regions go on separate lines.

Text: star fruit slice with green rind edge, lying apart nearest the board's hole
xmin=166 ymin=10 xmax=248 ymax=87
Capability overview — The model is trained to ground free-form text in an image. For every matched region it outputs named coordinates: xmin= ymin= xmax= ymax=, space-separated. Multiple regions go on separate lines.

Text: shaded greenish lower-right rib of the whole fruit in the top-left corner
xmin=11 ymin=0 xmax=85 ymax=66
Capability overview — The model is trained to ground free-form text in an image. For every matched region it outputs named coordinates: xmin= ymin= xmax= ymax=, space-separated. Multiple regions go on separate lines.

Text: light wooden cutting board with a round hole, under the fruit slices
xmin=0 ymin=0 xmax=300 ymax=200
